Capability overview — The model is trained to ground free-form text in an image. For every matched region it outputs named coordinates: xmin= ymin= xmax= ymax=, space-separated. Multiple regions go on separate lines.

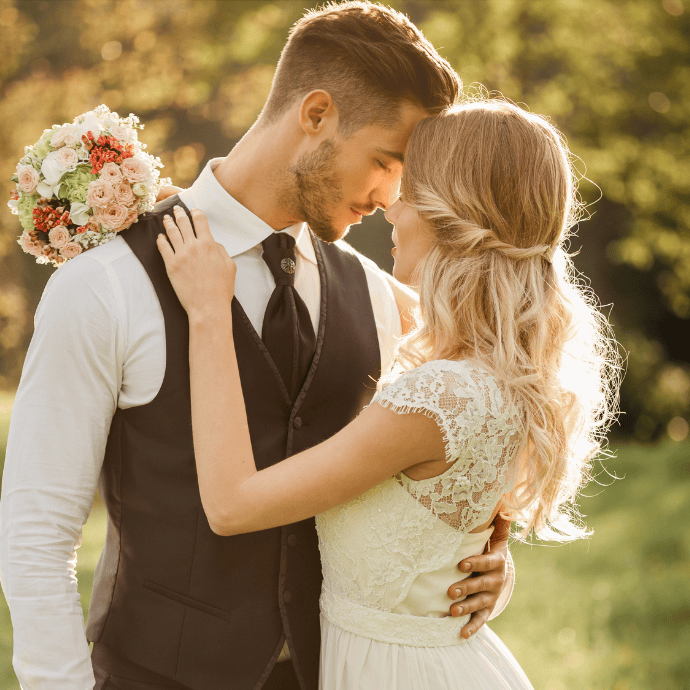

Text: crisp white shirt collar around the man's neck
xmin=180 ymin=158 xmax=316 ymax=264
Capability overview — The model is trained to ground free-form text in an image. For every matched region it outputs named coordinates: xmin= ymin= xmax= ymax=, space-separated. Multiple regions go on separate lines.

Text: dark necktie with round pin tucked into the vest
xmin=261 ymin=232 xmax=316 ymax=400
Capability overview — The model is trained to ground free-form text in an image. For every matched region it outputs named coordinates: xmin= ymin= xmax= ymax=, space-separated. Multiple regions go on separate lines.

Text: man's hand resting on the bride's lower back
xmin=448 ymin=516 xmax=510 ymax=639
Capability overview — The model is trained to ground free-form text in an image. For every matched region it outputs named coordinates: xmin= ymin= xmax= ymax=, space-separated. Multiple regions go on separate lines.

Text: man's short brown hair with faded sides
xmin=260 ymin=0 xmax=461 ymax=137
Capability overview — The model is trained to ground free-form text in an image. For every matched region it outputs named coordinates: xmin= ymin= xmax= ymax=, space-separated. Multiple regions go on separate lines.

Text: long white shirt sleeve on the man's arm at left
xmin=0 ymin=255 xmax=124 ymax=690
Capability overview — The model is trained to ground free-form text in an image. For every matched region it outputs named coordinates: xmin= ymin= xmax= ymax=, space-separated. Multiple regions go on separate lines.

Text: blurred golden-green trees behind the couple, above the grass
xmin=0 ymin=0 xmax=690 ymax=439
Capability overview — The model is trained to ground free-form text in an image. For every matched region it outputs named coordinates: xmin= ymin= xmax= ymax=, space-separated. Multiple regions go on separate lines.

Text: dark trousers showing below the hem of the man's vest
xmin=91 ymin=642 xmax=300 ymax=690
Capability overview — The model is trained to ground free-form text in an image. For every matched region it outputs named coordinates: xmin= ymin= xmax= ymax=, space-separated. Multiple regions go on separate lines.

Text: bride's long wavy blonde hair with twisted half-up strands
xmin=397 ymin=99 xmax=620 ymax=541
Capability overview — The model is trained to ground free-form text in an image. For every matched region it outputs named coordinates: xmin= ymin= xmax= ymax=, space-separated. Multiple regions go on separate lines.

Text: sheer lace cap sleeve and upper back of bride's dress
xmin=372 ymin=360 xmax=521 ymax=531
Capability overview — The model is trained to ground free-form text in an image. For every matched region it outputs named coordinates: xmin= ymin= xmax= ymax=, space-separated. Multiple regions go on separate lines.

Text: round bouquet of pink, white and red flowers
xmin=9 ymin=105 xmax=171 ymax=266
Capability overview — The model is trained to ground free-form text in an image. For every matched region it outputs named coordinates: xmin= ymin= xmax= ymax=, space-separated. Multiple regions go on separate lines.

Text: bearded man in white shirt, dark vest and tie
xmin=0 ymin=2 xmax=505 ymax=690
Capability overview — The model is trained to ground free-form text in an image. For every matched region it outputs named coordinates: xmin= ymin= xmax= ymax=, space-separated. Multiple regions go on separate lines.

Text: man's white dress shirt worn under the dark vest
xmin=0 ymin=159 xmax=401 ymax=690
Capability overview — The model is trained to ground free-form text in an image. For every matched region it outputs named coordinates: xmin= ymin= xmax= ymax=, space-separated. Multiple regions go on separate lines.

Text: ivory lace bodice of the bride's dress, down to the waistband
xmin=316 ymin=360 xmax=521 ymax=645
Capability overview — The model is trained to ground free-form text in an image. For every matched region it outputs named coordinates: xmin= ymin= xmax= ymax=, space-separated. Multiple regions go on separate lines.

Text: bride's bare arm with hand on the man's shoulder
xmin=159 ymin=210 xmax=445 ymax=535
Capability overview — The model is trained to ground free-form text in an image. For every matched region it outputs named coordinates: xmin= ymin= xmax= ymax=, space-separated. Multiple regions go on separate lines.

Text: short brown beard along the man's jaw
xmin=284 ymin=138 xmax=349 ymax=242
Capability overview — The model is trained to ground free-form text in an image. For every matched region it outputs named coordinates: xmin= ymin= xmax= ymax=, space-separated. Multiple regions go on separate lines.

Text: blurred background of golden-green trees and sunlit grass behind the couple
xmin=0 ymin=0 xmax=690 ymax=690
